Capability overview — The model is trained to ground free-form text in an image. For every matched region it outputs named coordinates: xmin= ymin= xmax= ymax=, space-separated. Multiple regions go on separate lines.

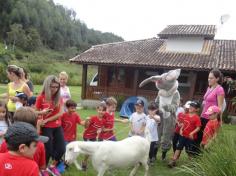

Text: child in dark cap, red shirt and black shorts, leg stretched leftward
xmin=168 ymin=101 xmax=201 ymax=167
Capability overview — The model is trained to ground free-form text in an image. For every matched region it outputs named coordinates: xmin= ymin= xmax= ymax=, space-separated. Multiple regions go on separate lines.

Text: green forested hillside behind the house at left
xmin=0 ymin=0 xmax=123 ymax=85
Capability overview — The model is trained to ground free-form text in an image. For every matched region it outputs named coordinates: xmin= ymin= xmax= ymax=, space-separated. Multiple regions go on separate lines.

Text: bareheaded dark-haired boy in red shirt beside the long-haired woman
xmin=61 ymin=100 xmax=85 ymax=144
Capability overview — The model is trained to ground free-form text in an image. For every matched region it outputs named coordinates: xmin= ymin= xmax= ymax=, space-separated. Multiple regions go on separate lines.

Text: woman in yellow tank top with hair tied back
xmin=7 ymin=65 xmax=31 ymax=115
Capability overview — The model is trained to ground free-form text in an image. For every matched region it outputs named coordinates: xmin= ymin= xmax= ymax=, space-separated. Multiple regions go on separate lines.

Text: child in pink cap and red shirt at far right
xmin=201 ymin=105 xmax=221 ymax=148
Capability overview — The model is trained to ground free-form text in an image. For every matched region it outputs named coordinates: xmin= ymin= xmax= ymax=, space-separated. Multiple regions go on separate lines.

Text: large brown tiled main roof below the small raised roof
xmin=71 ymin=38 xmax=236 ymax=72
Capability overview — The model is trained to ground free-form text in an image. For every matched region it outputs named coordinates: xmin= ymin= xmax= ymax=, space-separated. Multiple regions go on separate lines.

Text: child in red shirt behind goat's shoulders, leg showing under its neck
xmin=82 ymin=103 xmax=106 ymax=170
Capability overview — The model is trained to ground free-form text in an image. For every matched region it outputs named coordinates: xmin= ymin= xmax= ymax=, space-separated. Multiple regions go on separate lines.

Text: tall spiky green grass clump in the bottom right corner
xmin=181 ymin=133 xmax=236 ymax=176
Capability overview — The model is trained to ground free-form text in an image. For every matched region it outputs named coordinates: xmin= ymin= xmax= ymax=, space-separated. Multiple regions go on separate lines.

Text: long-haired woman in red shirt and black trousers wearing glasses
xmin=35 ymin=75 xmax=65 ymax=175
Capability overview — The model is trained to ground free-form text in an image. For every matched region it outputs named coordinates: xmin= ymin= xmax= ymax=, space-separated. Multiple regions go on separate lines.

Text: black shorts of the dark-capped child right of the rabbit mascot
xmin=176 ymin=135 xmax=195 ymax=154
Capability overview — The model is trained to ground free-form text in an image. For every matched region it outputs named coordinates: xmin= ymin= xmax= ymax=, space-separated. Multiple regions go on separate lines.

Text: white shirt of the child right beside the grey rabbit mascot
xmin=146 ymin=115 xmax=159 ymax=142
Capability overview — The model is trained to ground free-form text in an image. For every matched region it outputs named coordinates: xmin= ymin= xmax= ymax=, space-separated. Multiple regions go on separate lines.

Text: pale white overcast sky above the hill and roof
xmin=54 ymin=0 xmax=236 ymax=41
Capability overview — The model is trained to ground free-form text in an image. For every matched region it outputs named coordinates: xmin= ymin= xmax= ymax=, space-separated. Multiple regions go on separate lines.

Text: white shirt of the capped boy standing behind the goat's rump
xmin=129 ymin=112 xmax=146 ymax=136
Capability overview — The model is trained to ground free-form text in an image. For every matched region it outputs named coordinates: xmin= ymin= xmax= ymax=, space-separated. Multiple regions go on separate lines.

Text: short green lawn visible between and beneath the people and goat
xmin=0 ymin=85 xmax=236 ymax=176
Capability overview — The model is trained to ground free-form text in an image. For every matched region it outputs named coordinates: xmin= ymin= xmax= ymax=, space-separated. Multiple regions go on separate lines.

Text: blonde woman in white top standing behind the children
xmin=59 ymin=71 xmax=71 ymax=109
